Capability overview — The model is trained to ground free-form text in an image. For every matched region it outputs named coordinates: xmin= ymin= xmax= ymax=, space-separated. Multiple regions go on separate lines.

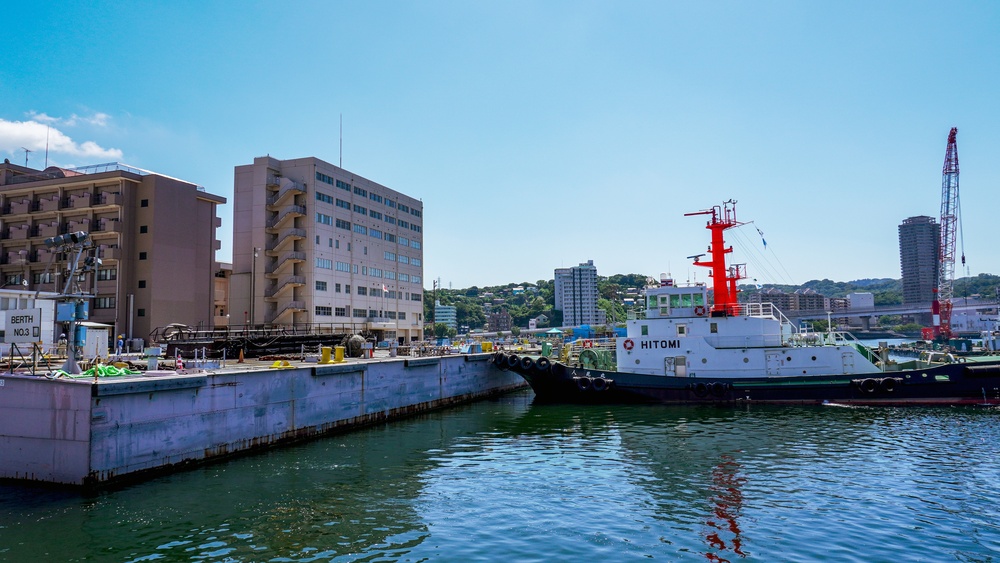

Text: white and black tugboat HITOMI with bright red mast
xmin=492 ymin=200 xmax=1000 ymax=405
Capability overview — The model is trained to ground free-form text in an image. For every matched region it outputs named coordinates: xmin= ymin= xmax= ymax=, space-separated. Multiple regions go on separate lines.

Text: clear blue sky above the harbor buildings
xmin=0 ymin=0 xmax=1000 ymax=288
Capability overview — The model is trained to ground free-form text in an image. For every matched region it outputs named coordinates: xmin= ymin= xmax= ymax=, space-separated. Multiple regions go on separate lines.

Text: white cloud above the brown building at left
xmin=0 ymin=117 xmax=122 ymax=166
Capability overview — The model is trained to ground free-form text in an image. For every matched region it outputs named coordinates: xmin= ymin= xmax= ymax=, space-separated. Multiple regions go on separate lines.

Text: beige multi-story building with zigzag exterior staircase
xmin=230 ymin=157 xmax=424 ymax=343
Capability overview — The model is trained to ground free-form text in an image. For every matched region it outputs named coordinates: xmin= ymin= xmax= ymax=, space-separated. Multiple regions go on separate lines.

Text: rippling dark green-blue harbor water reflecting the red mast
xmin=0 ymin=391 xmax=1000 ymax=562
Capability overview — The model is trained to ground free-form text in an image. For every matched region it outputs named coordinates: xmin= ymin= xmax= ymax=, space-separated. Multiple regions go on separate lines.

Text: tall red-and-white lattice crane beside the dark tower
xmin=921 ymin=127 xmax=965 ymax=340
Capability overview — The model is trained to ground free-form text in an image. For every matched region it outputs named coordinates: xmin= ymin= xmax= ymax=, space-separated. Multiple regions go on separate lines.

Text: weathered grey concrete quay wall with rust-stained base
xmin=0 ymin=354 xmax=524 ymax=485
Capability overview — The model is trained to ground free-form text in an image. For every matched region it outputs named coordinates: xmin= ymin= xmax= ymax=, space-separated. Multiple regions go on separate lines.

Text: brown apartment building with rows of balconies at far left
xmin=0 ymin=161 xmax=226 ymax=342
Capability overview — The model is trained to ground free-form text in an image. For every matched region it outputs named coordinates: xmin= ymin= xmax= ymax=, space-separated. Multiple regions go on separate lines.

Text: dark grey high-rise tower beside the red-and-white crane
xmin=899 ymin=215 xmax=941 ymax=304
